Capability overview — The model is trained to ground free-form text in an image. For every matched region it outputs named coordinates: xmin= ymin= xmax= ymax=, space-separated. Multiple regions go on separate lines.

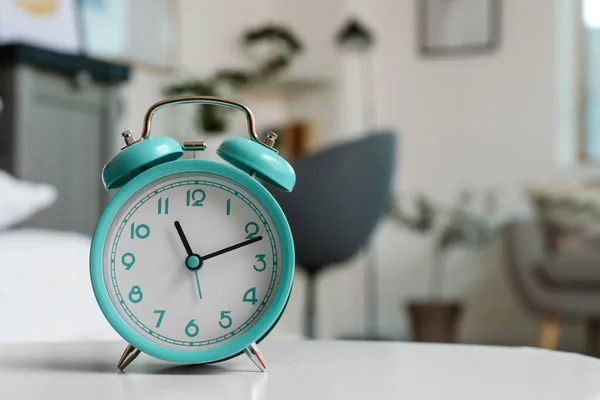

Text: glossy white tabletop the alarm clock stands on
xmin=0 ymin=341 xmax=600 ymax=400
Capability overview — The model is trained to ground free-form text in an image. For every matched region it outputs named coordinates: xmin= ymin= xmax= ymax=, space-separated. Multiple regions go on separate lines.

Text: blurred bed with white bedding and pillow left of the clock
xmin=0 ymin=170 xmax=118 ymax=342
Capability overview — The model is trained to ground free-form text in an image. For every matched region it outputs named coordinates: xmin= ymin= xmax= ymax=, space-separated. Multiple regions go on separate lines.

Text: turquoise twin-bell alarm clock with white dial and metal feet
xmin=90 ymin=96 xmax=296 ymax=371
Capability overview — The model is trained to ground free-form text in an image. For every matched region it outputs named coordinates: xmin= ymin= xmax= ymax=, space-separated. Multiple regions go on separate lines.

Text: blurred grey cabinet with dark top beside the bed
xmin=0 ymin=45 xmax=129 ymax=234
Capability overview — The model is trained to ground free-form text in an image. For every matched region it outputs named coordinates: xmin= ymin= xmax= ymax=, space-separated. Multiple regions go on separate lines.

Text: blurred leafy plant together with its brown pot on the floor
xmin=390 ymin=190 xmax=501 ymax=343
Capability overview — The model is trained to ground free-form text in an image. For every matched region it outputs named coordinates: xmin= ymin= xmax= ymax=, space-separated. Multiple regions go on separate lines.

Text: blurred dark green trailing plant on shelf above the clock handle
xmin=165 ymin=25 xmax=302 ymax=133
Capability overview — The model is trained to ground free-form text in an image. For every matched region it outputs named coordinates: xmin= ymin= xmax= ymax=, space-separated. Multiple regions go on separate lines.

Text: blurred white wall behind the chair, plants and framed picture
xmin=116 ymin=0 xmax=583 ymax=349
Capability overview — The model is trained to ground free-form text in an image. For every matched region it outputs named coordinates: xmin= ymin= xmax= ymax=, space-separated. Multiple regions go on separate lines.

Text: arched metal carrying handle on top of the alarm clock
xmin=139 ymin=96 xmax=262 ymax=142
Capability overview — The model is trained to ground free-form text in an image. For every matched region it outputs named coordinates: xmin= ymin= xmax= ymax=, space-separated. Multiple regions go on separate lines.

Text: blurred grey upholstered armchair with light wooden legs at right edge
xmin=506 ymin=221 xmax=600 ymax=356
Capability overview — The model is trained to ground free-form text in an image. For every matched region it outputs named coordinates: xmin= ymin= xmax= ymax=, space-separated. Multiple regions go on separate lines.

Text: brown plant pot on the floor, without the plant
xmin=408 ymin=301 xmax=463 ymax=343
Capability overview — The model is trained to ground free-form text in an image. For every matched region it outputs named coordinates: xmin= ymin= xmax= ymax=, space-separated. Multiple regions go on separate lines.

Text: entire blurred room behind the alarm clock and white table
xmin=0 ymin=0 xmax=600 ymax=356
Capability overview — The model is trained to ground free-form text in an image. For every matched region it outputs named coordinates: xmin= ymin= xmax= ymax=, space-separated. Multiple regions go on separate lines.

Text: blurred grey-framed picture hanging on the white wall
xmin=415 ymin=0 xmax=502 ymax=56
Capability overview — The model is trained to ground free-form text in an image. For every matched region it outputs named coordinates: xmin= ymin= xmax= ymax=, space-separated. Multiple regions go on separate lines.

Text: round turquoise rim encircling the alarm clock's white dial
xmin=90 ymin=159 xmax=295 ymax=364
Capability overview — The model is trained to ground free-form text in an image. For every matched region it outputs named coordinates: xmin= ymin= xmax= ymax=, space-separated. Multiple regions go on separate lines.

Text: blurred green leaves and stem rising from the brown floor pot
xmin=390 ymin=190 xmax=502 ymax=298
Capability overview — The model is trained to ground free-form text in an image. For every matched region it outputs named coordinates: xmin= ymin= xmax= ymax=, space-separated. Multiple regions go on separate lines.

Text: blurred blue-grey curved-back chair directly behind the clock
xmin=273 ymin=132 xmax=396 ymax=338
